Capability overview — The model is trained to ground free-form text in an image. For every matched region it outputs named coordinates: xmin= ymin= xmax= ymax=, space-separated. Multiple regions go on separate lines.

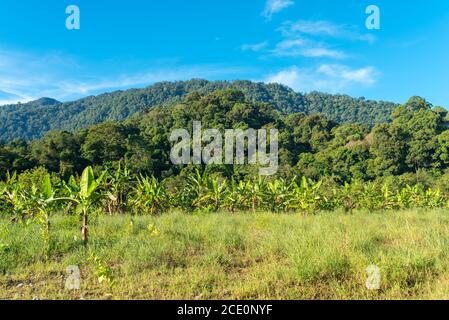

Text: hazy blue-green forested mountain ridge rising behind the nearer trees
xmin=0 ymin=80 xmax=397 ymax=141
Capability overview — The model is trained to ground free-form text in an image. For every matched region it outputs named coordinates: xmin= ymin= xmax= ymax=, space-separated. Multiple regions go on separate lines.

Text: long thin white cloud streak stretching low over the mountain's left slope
xmin=0 ymin=49 xmax=248 ymax=105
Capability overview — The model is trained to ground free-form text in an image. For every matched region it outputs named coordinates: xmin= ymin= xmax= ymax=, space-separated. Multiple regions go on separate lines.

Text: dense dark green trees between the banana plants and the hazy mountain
xmin=0 ymin=90 xmax=449 ymax=188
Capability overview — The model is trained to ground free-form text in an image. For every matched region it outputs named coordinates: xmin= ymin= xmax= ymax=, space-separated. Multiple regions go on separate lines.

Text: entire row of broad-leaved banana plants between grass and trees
xmin=0 ymin=167 xmax=449 ymax=252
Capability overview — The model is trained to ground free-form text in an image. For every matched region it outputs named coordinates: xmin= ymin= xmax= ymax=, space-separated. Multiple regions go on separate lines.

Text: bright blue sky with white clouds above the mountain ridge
xmin=0 ymin=0 xmax=449 ymax=107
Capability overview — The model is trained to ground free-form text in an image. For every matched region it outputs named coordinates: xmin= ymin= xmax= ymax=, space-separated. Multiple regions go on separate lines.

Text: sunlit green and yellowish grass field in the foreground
xmin=0 ymin=210 xmax=449 ymax=299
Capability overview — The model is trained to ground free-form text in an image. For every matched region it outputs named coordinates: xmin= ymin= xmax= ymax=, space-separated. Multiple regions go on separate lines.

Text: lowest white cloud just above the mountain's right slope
xmin=264 ymin=64 xmax=379 ymax=93
